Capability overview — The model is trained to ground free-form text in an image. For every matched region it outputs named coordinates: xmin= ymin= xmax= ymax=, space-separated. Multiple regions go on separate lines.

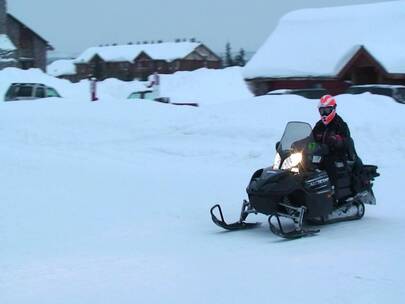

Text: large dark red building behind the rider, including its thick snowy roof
xmin=244 ymin=1 xmax=405 ymax=95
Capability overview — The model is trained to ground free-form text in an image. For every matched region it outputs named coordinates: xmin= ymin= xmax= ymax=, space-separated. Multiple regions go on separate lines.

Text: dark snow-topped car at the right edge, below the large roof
xmin=345 ymin=84 xmax=405 ymax=103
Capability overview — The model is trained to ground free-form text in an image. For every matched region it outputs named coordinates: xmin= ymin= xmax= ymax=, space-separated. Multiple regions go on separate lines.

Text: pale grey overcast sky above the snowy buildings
xmin=7 ymin=0 xmax=392 ymax=54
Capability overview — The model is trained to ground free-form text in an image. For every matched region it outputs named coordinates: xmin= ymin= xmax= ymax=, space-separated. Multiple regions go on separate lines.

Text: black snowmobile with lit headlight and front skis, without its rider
xmin=210 ymin=122 xmax=379 ymax=239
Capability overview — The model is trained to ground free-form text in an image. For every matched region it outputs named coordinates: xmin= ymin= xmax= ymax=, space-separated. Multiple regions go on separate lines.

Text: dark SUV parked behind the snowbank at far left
xmin=4 ymin=83 xmax=61 ymax=101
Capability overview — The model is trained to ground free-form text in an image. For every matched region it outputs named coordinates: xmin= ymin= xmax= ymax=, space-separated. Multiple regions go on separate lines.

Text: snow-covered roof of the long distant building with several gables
xmin=75 ymin=42 xmax=201 ymax=63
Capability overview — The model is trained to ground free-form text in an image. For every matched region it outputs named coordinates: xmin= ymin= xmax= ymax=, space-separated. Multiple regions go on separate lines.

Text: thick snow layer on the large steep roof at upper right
xmin=244 ymin=1 xmax=405 ymax=79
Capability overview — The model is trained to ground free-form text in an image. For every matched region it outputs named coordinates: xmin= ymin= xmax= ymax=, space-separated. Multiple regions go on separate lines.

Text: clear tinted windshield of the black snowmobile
xmin=278 ymin=121 xmax=312 ymax=153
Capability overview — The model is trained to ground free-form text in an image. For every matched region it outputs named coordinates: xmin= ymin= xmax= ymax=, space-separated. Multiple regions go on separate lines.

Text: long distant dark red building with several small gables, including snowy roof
xmin=74 ymin=42 xmax=222 ymax=81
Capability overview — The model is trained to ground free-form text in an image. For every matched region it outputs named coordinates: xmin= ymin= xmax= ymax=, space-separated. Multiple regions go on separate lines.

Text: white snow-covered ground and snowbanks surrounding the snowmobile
xmin=0 ymin=70 xmax=405 ymax=304
